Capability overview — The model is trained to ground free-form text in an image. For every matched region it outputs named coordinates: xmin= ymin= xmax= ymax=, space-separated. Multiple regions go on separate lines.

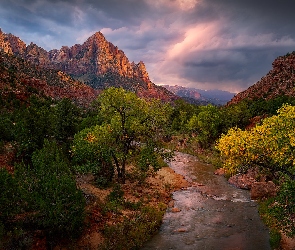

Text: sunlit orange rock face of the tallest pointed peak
xmin=48 ymin=32 xmax=150 ymax=82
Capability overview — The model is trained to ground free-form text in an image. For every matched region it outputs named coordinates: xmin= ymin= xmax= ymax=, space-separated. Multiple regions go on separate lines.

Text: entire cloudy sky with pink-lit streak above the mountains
xmin=0 ymin=0 xmax=295 ymax=92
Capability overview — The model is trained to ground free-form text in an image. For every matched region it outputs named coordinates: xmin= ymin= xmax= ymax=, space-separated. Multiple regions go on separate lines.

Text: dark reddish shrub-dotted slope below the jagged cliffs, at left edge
xmin=0 ymin=50 xmax=98 ymax=106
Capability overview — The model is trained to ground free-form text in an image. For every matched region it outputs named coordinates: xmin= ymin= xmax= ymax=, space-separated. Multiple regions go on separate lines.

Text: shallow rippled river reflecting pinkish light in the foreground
xmin=141 ymin=153 xmax=271 ymax=250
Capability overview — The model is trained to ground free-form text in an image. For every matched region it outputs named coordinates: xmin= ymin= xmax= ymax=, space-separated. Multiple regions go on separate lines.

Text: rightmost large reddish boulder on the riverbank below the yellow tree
xmin=251 ymin=181 xmax=277 ymax=200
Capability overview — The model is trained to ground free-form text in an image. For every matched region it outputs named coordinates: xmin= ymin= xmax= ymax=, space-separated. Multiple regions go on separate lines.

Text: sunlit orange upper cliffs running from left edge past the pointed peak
xmin=0 ymin=30 xmax=150 ymax=83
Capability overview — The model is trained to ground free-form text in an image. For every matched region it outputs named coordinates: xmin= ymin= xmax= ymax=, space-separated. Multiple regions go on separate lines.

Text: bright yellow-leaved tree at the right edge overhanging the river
xmin=216 ymin=105 xmax=295 ymax=175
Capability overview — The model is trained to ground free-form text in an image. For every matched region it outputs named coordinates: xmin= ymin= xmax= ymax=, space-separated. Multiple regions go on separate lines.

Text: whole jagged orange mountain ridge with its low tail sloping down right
xmin=0 ymin=29 xmax=177 ymax=101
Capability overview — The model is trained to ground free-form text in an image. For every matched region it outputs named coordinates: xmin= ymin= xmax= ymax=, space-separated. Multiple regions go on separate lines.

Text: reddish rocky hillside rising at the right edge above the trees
xmin=227 ymin=52 xmax=295 ymax=105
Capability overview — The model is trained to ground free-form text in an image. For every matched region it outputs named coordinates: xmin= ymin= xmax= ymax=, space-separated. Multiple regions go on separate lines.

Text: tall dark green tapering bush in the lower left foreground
xmin=30 ymin=141 xmax=85 ymax=236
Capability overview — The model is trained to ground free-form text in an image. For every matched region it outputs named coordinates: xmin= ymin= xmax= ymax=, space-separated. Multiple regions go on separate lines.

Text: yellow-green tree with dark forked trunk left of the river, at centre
xmin=73 ymin=88 xmax=171 ymax=183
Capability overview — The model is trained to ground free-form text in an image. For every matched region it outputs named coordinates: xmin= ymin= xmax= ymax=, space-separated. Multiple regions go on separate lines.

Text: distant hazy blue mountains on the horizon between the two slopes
xmin=163 ymin=85 xmax=235 ymax=105
